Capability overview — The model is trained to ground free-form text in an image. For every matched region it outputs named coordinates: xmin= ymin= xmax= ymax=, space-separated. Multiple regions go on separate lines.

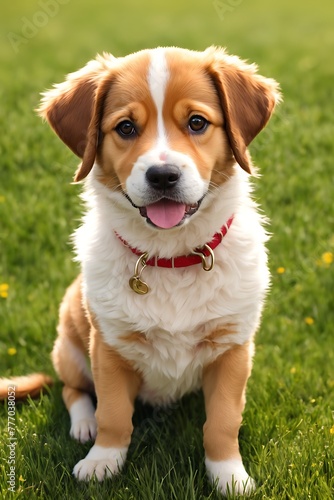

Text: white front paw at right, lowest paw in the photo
xmin=205 ymin=458 xmax=255 ymax=495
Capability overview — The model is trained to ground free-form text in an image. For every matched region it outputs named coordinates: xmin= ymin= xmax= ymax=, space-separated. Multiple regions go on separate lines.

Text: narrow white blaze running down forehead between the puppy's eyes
xmin=148 ymin=48 xmax=169 ymax=149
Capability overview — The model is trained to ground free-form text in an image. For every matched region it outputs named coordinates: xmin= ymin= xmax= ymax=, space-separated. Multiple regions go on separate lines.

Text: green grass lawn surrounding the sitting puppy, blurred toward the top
xmin=0 ymin=0 xmax=334 ymax=500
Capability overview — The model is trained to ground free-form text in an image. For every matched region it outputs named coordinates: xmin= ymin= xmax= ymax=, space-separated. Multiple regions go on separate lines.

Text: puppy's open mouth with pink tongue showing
xmin=139 ymin=198 xmax=202 ymax=229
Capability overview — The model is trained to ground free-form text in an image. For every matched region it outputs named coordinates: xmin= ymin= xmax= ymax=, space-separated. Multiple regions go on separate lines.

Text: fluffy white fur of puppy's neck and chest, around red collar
xmin=75 ymin=166 xmax=269 ymax=404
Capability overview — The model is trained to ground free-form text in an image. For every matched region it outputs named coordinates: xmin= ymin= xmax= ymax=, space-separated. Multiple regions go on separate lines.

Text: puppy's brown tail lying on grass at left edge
xmin=0 ymin=373 xmax=53 ymax=401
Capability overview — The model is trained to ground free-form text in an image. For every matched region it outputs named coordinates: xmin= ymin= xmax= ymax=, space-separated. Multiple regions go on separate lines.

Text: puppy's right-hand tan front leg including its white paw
xmin=203 ymin=343 xmax=255 ymax=494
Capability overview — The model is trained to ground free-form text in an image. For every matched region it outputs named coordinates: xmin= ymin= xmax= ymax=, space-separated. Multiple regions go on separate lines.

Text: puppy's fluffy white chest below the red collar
xmin=84 ymin=231 xmax=268 ymax=404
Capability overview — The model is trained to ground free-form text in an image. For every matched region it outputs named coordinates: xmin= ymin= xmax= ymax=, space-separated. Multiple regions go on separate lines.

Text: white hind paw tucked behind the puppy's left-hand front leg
xmin=69 ymin=394 xmax=97 ymax=443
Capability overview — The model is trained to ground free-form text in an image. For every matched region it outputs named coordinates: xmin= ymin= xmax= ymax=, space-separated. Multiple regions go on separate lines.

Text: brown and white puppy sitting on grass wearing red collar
xmin=1 ymin=47 xmax=280 ymax=494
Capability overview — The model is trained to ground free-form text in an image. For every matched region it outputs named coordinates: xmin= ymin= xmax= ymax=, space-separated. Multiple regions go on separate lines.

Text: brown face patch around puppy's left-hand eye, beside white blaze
xmin=81 ymin=51 xmax=156 ymax=189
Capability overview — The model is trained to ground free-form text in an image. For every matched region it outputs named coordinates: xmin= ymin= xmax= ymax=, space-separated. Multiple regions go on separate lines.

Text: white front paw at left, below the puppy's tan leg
xmin=73 ymin=445 xmax=127 ymax=481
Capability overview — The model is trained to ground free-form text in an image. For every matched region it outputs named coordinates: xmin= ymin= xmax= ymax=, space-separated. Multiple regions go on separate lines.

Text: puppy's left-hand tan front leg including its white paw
xmin=73 ymin=331 xmax=141 ymax=481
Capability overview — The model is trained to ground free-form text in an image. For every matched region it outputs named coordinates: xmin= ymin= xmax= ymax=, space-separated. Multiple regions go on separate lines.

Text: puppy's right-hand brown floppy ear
xmin=208 ymin=48 xmax=280 ymax=173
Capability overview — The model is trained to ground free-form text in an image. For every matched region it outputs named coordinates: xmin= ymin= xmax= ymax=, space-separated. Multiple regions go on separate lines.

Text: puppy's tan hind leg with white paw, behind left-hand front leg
xmin=52 ymin=276 xmax=96 ymax=442
